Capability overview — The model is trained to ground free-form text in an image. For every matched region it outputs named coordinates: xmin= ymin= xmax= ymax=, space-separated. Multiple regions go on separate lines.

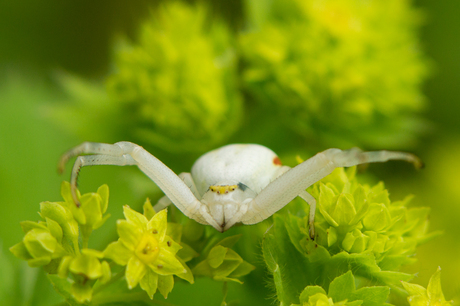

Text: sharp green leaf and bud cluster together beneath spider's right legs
xmin=263 ymin=167 xmax=439 ymax=305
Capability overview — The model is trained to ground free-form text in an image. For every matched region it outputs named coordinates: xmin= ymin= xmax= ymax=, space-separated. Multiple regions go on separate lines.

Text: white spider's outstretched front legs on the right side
xmin=241 ymin=148 xmax=423 ymax=238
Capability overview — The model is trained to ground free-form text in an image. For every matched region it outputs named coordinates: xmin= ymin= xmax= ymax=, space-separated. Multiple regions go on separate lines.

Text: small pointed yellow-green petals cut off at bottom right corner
xmin=402 ymin=268 xmax=453 ymax=306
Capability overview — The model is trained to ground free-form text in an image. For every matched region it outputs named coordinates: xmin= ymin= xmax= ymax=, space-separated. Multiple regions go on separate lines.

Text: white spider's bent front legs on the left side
xmin=59 ymin=141 xmax=203 ymax=225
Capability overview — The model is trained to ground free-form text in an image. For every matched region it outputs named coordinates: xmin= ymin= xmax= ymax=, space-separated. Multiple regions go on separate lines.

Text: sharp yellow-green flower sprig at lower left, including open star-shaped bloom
xmin=10 ymin=182 xmax=254 ymax=305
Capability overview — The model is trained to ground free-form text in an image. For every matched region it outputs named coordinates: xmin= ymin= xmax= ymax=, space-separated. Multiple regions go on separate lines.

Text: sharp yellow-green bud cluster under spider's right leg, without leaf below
xmin=309 ymin=167 xmax=438 ymax=270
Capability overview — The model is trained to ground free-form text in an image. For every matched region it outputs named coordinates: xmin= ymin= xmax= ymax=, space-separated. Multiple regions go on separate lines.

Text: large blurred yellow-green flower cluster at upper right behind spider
xmin=239 ymin=0 xmax=428 ymax=147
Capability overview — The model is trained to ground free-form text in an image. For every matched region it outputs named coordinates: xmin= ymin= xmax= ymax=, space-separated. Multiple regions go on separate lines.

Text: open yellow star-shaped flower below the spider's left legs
xmin=104 ymin=205 xmax=193 ymax=298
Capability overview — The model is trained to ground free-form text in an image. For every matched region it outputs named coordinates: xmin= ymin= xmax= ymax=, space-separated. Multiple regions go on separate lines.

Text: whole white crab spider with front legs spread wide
xmin=59 ymin=141 xmax=422 ymax=238
